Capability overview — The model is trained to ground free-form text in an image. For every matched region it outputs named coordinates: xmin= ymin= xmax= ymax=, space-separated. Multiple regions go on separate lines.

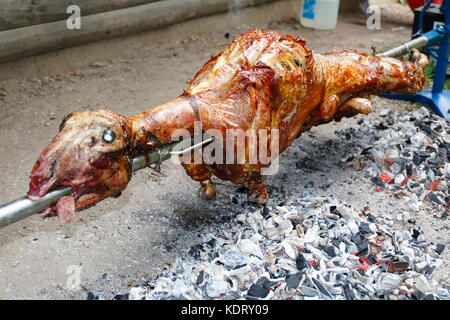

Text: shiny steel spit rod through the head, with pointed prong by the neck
xmin=0 ymin=137 xmax=214 ymax=228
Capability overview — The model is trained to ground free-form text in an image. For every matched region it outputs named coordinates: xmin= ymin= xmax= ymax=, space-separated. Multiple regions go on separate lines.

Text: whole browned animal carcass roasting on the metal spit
xmin=29 ymin=30 xmax=425 ymax=220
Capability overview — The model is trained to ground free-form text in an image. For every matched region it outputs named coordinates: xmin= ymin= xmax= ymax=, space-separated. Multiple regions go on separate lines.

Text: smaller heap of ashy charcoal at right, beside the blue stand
xmin=336 ymin=107 xmax=450 ymax=219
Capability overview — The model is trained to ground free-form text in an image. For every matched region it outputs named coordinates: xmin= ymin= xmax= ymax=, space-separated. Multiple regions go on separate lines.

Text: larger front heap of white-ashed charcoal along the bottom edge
xmin=118 ymin=192 xmax=449 ymax=300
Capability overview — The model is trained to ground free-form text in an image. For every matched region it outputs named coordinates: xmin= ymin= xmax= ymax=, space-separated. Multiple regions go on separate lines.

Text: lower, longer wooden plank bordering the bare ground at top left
xmin=0 ymin=0 xmax=278 ymax=63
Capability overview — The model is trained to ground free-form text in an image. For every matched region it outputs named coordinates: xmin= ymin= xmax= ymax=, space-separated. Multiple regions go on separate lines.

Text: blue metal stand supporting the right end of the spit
xmin=381 ymin=0 xmax=450 ymax=119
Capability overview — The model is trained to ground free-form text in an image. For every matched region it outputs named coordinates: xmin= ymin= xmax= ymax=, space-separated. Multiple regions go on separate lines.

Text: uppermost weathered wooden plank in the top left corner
xmin=0 ymin=0 xmax=162 ymax=31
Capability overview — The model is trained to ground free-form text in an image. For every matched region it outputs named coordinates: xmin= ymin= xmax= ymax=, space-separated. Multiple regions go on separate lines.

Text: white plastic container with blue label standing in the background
xmin=300 ymin=0 xmax=339 ymax=30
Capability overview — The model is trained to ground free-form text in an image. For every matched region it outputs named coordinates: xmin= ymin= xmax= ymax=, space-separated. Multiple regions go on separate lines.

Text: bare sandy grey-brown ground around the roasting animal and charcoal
xmin=0 ymin=1 xmax=447 ymax=299
